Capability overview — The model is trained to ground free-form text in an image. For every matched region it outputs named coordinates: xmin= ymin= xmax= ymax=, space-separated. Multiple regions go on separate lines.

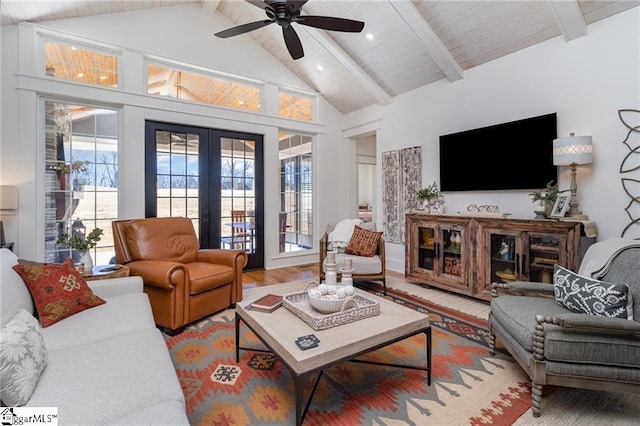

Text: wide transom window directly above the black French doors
xmin=147 ymin=64 xmax=261 ymax=112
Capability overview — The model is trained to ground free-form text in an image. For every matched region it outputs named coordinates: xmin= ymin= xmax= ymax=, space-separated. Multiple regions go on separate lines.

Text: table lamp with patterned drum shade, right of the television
xmin=553 ymin=133 xmax=593 ymax=220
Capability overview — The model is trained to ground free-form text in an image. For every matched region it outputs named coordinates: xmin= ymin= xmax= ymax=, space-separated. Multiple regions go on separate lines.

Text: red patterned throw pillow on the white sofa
xmin=13 ymin=259 xmax=106 ymax=328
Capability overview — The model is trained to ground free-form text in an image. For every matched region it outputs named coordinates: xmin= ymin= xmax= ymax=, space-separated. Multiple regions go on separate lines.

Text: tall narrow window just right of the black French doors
xmin=279 ymin=134 xmax=313 ymax=253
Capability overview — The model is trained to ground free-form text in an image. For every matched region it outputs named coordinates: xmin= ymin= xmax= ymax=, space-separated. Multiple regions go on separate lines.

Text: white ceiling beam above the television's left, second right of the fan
xmin=387 ymin=0 xmax=464 ymax=81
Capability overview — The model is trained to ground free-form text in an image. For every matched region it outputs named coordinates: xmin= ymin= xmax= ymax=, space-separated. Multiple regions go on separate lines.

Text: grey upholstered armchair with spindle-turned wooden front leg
xmin=489 ymin=238 xmax=640 ymax=417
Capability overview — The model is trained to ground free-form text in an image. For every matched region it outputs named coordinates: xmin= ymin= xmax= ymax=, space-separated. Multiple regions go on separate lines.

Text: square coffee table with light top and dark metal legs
xmin=235 ymin=282 xmax=431 ymax=425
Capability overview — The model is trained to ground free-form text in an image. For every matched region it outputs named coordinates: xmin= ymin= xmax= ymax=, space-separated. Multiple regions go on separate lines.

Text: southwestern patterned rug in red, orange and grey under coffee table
xmin=165 ymin=282 xmax=530 ymax=426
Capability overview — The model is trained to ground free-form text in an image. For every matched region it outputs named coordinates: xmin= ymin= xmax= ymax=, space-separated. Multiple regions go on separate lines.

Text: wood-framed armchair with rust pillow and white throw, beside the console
xmin=319 ymin=220 xmax=387 ymax=295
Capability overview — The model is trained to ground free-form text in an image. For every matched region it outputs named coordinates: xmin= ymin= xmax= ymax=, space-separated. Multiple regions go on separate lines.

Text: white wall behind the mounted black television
xmin=345 ymin=8 xmax=640 ymax=271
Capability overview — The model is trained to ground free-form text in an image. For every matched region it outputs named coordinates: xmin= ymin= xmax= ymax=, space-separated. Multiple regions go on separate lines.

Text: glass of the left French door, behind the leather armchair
xmin=156 ymin=130 xmax=200 ymax=235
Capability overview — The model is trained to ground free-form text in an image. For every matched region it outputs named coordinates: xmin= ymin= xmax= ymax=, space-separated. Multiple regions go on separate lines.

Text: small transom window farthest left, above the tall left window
xmin=44 ymin=40 xmax=118 ymax=87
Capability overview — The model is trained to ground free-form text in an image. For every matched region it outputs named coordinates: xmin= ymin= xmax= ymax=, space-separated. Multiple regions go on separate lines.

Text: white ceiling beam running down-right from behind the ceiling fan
xmin=296 ymin=25 xmax=391 ymax=105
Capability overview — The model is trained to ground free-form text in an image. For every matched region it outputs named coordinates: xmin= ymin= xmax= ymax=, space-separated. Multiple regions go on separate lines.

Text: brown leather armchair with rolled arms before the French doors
xmin=112 ymin=217 xmax=247 ymax=334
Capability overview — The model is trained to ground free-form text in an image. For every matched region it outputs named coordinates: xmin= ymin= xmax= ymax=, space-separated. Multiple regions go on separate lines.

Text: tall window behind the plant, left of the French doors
xmin=45 ymin=101 xmax=118 ymax=265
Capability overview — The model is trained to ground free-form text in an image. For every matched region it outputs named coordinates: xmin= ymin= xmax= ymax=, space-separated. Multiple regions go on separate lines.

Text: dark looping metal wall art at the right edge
xmin=618 ymin=109 xmax=640 ymax=239
